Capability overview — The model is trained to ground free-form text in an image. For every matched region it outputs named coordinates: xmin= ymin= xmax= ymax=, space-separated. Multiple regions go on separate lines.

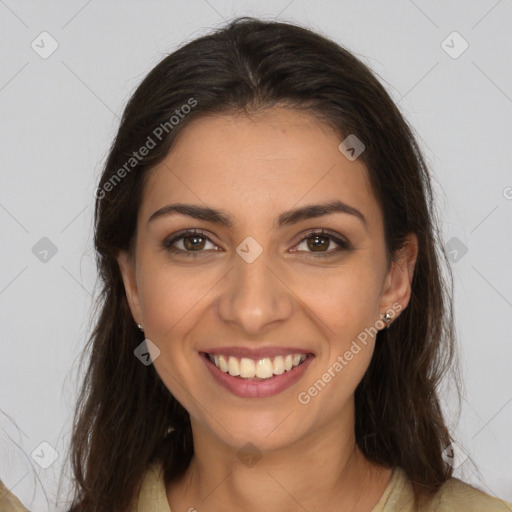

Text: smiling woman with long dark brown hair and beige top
xmin=62 ymin=18 xmax=510 ymax=512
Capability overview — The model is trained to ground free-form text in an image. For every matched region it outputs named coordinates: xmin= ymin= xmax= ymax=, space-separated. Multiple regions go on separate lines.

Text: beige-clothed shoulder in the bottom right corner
xmin=435 ymin=478 xmax=512 ymax=512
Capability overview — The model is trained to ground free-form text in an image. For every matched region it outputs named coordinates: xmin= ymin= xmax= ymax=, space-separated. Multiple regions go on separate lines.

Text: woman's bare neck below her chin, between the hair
xmin=167 ymin=406 xmax=391 ymax=512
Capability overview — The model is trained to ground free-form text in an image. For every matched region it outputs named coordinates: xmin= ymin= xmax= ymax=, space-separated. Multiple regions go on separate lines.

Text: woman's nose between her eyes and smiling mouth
xmin=217 ymin=245 xmax=294 ymax=336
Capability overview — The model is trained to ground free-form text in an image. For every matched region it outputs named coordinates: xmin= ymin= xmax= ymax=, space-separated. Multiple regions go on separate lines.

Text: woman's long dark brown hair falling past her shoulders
xmin=65 ymin=18 xmax=455 ymax=512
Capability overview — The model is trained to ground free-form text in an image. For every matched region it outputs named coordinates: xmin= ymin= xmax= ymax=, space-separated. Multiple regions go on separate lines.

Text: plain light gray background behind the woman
xmin=0 ymin=0 xmax=512 ymax=511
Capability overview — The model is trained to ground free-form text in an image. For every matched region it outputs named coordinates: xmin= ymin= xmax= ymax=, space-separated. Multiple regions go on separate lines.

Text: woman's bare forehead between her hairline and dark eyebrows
xmin=140 ymin=107 xmax=380 ymax=233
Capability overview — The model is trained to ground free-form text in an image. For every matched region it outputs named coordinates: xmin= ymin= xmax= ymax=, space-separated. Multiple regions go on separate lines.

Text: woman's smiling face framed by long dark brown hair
xmin=119 ymin=107 xmax=414 ymax=449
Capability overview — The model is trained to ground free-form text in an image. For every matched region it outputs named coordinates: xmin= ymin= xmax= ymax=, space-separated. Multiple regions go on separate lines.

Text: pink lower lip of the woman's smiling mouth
xmin=200 ymin=352 xmax=313 ymax=398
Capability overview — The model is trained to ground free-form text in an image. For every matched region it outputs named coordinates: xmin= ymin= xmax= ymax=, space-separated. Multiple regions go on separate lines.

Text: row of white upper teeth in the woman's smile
xmin=208 ymin=354 xmax=307 ymax=379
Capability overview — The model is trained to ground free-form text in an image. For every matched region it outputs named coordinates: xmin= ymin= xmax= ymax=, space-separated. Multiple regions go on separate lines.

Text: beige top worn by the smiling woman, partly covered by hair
xmin=0 ymin=465 xmax=512 ymax=512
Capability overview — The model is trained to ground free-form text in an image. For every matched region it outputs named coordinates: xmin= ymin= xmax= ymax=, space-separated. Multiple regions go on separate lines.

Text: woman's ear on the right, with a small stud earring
xmin=380 ymin=233 xmax=418 ymax=320
